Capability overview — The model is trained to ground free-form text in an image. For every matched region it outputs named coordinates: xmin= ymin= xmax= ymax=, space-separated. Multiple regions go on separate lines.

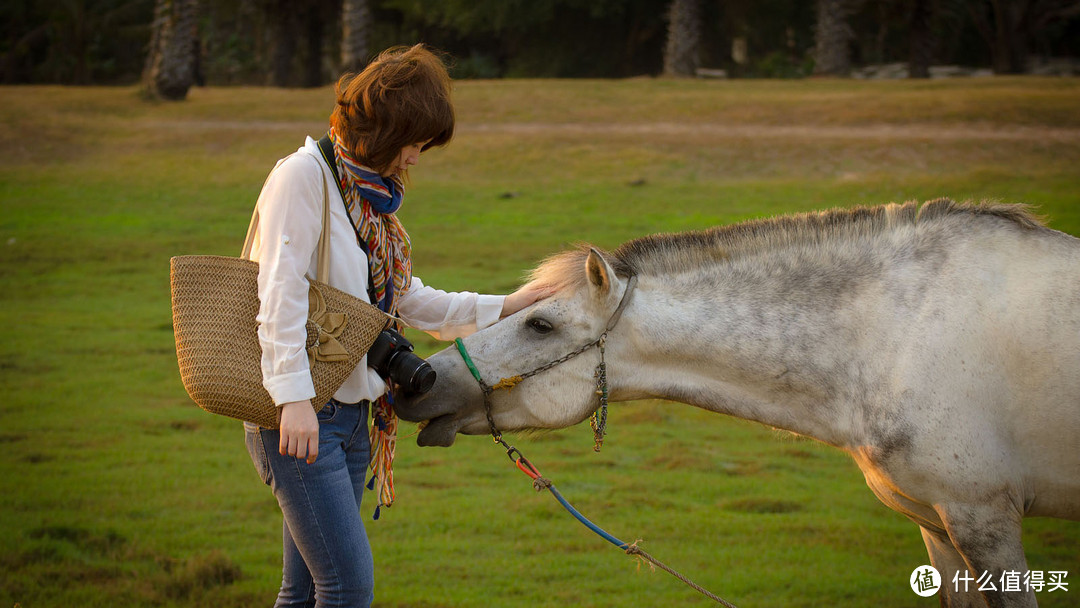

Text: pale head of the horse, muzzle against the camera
xmin=394 ymin=248 xmax=632 ymax=446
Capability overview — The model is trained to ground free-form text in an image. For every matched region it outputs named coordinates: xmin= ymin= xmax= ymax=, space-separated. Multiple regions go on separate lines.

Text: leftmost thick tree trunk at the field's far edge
xmin=143 ymin=0 xmax=199 ymax=100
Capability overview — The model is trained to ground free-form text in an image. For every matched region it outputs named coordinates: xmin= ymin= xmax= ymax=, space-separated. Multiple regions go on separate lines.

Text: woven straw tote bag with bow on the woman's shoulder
xmin=170 ymin=156 xmax=390 ymax=429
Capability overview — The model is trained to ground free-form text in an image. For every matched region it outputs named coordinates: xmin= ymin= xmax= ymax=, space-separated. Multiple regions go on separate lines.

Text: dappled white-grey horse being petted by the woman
xmin=396 ymin=200 xmax=1080 ymax=607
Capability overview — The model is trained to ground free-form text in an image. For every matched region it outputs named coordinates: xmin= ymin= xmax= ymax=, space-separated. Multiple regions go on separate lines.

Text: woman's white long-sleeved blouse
xmin=251 ymin=137 xmax=505 ymax=405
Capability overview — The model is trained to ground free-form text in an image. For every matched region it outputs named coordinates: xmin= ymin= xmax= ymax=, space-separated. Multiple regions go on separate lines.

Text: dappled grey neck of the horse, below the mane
xmin=612 ymin=244 xmax=911 ymax=447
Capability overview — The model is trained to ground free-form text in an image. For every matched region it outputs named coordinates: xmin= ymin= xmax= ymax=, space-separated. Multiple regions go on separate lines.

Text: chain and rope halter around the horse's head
xmin=454 ymin=274 xmax=637 ymax=454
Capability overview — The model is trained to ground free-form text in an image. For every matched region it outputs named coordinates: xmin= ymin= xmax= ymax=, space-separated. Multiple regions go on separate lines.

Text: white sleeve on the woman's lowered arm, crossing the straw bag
xmin=253 ymin=153 xmax=323 ymax=406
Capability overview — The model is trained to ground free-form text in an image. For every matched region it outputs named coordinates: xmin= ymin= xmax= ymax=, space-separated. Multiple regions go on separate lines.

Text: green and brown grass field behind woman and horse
xmin=0 ymin=78 xmax=1080 ymax=608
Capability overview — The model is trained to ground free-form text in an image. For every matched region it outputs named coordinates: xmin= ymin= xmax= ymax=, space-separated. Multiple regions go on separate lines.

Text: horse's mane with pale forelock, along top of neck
xmin=528 ymin=199 xmax=1044 ymax=291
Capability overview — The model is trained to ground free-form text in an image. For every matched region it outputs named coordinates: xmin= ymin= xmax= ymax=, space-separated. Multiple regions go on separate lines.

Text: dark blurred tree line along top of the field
xmin=0 ymin=0 xmax=1080 ymax=96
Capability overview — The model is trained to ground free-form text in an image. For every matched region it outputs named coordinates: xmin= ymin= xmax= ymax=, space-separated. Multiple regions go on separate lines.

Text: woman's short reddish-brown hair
xmin=330 ymin=44 xmax=454 ymax=173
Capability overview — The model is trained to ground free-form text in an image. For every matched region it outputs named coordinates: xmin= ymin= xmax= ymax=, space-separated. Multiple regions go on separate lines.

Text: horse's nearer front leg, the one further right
xmin=937 ymin=501 xmax=1038 ymax=608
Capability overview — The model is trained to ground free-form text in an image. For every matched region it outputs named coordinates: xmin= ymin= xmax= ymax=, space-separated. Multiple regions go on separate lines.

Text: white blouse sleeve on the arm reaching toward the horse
xmin=397 ymin=276 xmax=507 ymax=340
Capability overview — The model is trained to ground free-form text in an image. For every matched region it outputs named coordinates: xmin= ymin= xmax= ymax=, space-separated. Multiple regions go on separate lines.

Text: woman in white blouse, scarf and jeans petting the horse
xmin=245 ymin=44 xmax=540 ymax=607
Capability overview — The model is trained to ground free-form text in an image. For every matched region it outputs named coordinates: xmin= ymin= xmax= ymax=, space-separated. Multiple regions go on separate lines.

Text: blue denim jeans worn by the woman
xmin=244 ymin=400 xmax=375 ymax=608
